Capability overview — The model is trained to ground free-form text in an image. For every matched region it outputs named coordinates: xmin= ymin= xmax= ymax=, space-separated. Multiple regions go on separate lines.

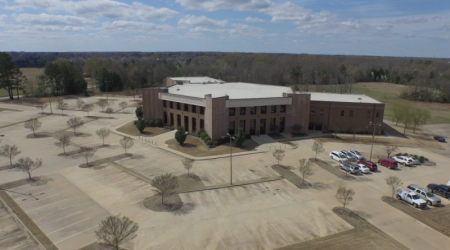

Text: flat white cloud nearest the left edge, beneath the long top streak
xmin=15 ymin=13 xmax=95 ymax=26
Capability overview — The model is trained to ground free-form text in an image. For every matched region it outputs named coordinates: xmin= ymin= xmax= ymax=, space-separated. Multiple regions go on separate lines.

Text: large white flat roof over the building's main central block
xmin=169 ymin=82 xmax=292 ymax=99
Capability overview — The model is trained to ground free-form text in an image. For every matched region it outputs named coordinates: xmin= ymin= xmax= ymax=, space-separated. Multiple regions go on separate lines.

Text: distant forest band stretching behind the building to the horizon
xmin=9 ymin=52 xmax=450 ymax=102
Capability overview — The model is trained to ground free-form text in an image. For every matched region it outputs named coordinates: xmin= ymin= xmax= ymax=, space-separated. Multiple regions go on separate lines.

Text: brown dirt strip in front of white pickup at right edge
xmin=381 ymin=196 xmax=450 ymax=237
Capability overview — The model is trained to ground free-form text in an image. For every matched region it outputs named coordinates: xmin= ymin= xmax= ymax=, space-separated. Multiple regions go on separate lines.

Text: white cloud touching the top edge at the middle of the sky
xmin=176 ymin=0 xmax=270 ymax=11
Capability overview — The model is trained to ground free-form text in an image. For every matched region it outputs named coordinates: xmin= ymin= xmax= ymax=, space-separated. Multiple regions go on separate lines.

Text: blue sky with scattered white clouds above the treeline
xmin=0 ymin=0 xmax=450 ymax=58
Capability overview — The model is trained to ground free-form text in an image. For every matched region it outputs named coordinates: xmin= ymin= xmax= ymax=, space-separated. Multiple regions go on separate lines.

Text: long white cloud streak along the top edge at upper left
xmin=15 ymin=0 xmax=178 ymax=20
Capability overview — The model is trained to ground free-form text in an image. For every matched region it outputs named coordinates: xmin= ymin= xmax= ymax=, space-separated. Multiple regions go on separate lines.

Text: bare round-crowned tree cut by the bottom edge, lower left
xmin=95 ymin=215 xmax=139 ymax=250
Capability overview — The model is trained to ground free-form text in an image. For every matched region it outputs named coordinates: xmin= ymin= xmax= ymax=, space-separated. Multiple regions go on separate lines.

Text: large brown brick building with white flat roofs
xmin=142 ymin=77 xmax=384 ymax=140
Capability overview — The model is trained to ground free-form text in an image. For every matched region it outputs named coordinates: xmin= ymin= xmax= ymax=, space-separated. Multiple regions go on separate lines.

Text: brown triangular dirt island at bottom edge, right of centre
xmin=278 ymin=207 xmax=408 ymax=250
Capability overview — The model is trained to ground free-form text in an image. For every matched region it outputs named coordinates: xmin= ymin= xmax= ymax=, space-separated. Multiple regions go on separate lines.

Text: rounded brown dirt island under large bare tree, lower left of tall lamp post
xmin=144 ymin=194 xmax=195 ymax=215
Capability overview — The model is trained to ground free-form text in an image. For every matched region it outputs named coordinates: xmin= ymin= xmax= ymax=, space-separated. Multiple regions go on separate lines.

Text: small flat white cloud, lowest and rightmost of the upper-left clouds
xmin=100 ymin=20 xmax=172 ymax=33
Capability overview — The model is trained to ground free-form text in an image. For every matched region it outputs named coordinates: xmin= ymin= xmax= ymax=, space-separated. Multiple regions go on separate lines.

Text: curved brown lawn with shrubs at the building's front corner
xmin=166 ymin=136 xmax=259 ymax=157
